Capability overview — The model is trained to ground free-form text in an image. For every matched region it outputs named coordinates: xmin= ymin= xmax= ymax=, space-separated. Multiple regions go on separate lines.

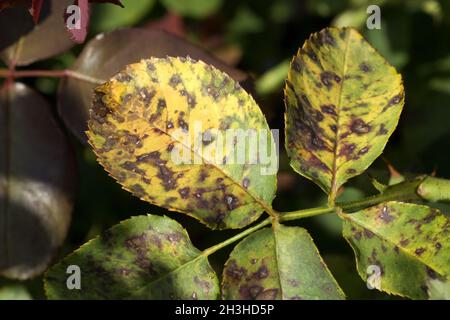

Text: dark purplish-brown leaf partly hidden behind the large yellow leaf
xmin=58 ymin=28 xmax=249 ymax=142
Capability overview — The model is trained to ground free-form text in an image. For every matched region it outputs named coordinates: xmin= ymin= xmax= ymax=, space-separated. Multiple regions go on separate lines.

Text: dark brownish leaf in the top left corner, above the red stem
xmin=0 ymin=0 xmax=74 ymax=66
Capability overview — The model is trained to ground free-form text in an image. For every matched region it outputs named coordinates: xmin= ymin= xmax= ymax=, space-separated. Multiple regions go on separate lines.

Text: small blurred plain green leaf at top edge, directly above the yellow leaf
xmin=161 ymin=0 xmax=222 ymax=18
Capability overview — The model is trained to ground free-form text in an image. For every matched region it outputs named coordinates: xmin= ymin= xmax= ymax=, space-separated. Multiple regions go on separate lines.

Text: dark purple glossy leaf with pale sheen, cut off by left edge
xmin=0 ymin=83 xmax=76 ymax=279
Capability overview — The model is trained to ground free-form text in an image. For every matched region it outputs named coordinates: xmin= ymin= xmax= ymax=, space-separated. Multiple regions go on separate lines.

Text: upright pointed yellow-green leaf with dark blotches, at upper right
xmin=285 ymin=28 xmax=404 ymax=203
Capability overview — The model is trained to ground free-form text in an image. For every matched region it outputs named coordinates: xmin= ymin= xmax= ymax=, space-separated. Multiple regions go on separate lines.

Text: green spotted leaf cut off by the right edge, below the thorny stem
xmin=340 ymin=202 xmax=450 ymax=299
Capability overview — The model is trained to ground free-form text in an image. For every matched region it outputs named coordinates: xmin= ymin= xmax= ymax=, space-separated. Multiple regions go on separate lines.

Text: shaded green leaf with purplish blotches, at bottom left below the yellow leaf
xmin=45 ymin=215 xmax=219 ymax=300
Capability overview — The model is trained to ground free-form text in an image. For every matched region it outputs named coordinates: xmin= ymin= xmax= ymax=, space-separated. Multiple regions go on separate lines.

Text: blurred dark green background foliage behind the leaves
xmin=0 ymin=0 xmax=450 ymax=299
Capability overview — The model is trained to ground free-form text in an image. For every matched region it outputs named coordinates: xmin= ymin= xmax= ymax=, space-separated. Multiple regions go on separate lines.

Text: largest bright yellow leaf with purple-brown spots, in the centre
xmin=87 ymin=58 xmax=277 ymax=228
